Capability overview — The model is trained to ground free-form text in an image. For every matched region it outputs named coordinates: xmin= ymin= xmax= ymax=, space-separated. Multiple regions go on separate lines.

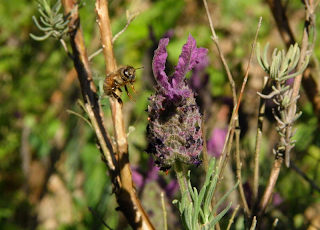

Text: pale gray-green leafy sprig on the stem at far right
xmin=256 ymin=43 xmax=309 ymax=167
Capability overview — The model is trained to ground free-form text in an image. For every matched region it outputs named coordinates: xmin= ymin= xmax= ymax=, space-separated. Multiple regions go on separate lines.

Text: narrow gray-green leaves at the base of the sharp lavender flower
xmin=173 ymin=158 xmax=239 ymax=230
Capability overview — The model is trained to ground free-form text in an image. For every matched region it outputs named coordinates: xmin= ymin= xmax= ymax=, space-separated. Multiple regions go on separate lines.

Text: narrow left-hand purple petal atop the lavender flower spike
xmin=152 ymin=38 xmax=172 ymax=91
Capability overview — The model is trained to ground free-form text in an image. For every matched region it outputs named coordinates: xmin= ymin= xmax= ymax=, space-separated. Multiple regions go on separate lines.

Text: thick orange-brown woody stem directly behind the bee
xmin=96 ymin=0 xmax=154 ymax=230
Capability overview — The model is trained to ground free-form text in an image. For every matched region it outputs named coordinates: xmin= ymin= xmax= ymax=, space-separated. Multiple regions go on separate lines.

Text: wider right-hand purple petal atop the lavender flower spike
xmin=172 ymin=34 xmax=208 ymax=88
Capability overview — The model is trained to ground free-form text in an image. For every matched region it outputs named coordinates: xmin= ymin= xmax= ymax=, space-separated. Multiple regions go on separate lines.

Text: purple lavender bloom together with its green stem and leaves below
xmin=146 ymin=35 xmax=237 ymax=230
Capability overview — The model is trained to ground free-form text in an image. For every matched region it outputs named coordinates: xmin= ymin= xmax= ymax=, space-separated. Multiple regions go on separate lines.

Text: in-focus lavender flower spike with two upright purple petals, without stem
xmin=146 ymin=35 xmax=208 ymax=171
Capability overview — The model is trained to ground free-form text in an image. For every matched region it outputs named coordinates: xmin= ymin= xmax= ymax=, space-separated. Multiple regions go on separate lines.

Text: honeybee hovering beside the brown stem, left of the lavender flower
xmin=103 ymin=65 xmax=136 ymax=106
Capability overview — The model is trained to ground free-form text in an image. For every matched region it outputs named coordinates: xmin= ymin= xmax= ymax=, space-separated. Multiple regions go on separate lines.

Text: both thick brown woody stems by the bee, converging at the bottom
xmin=62 ymin=0 xmax=154 ymax=229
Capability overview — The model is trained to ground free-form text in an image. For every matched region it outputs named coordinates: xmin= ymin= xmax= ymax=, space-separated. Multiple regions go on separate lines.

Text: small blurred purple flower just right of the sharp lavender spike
xmin=207 ymin=127 xmax=228 ymax=157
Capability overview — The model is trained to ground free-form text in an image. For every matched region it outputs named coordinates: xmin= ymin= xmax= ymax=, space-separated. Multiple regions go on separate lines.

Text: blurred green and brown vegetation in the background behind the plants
xmin=0 ymin=0 xmax=320 ymax=230
